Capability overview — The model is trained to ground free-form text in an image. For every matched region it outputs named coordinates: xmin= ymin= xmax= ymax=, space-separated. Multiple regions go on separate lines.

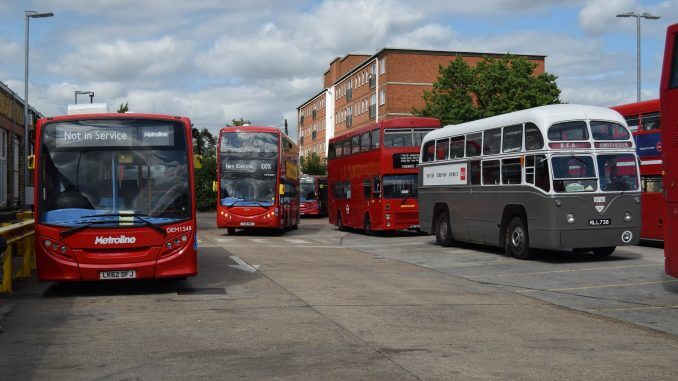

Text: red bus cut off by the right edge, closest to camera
xmin=659 ymin=24 xmax=678 ymax=277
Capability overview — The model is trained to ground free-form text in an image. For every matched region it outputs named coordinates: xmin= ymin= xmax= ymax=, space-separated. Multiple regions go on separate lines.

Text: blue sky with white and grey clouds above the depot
xmin=0 ymin=0 xmax=678 ymax=136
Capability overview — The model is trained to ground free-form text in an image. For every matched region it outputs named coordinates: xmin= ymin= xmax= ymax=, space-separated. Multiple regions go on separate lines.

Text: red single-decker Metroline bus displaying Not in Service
xmin=33 ymin=113 xmax=197 ymax=281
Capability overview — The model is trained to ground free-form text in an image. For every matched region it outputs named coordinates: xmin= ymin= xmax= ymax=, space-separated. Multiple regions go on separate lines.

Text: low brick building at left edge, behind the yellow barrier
xmin=0 ymin=82 xmax=42 ymax=221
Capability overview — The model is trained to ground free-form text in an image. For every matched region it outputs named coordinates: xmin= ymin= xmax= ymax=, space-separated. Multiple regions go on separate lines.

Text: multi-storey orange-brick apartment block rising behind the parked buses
xmin=297 ymin=48 xmax=545 ymax=157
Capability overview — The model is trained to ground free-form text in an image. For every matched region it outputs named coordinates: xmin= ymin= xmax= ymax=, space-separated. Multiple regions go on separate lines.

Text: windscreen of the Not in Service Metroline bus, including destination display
xmin=39 ymin=119 xmax=191 ymax=226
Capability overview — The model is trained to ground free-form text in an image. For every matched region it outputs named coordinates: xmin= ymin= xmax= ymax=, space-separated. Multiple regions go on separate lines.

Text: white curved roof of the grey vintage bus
xmin=422 ymin=104 xmax=626 ymax=143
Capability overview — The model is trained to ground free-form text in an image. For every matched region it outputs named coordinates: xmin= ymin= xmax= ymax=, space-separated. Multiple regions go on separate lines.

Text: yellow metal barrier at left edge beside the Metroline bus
xmin=0 ymin=219 xmax=35 ymax=292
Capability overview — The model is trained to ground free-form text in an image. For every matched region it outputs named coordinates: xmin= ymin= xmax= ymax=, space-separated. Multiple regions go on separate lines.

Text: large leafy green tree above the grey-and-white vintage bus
xmin=413 ymin=55 xmax=561 ymax=125
